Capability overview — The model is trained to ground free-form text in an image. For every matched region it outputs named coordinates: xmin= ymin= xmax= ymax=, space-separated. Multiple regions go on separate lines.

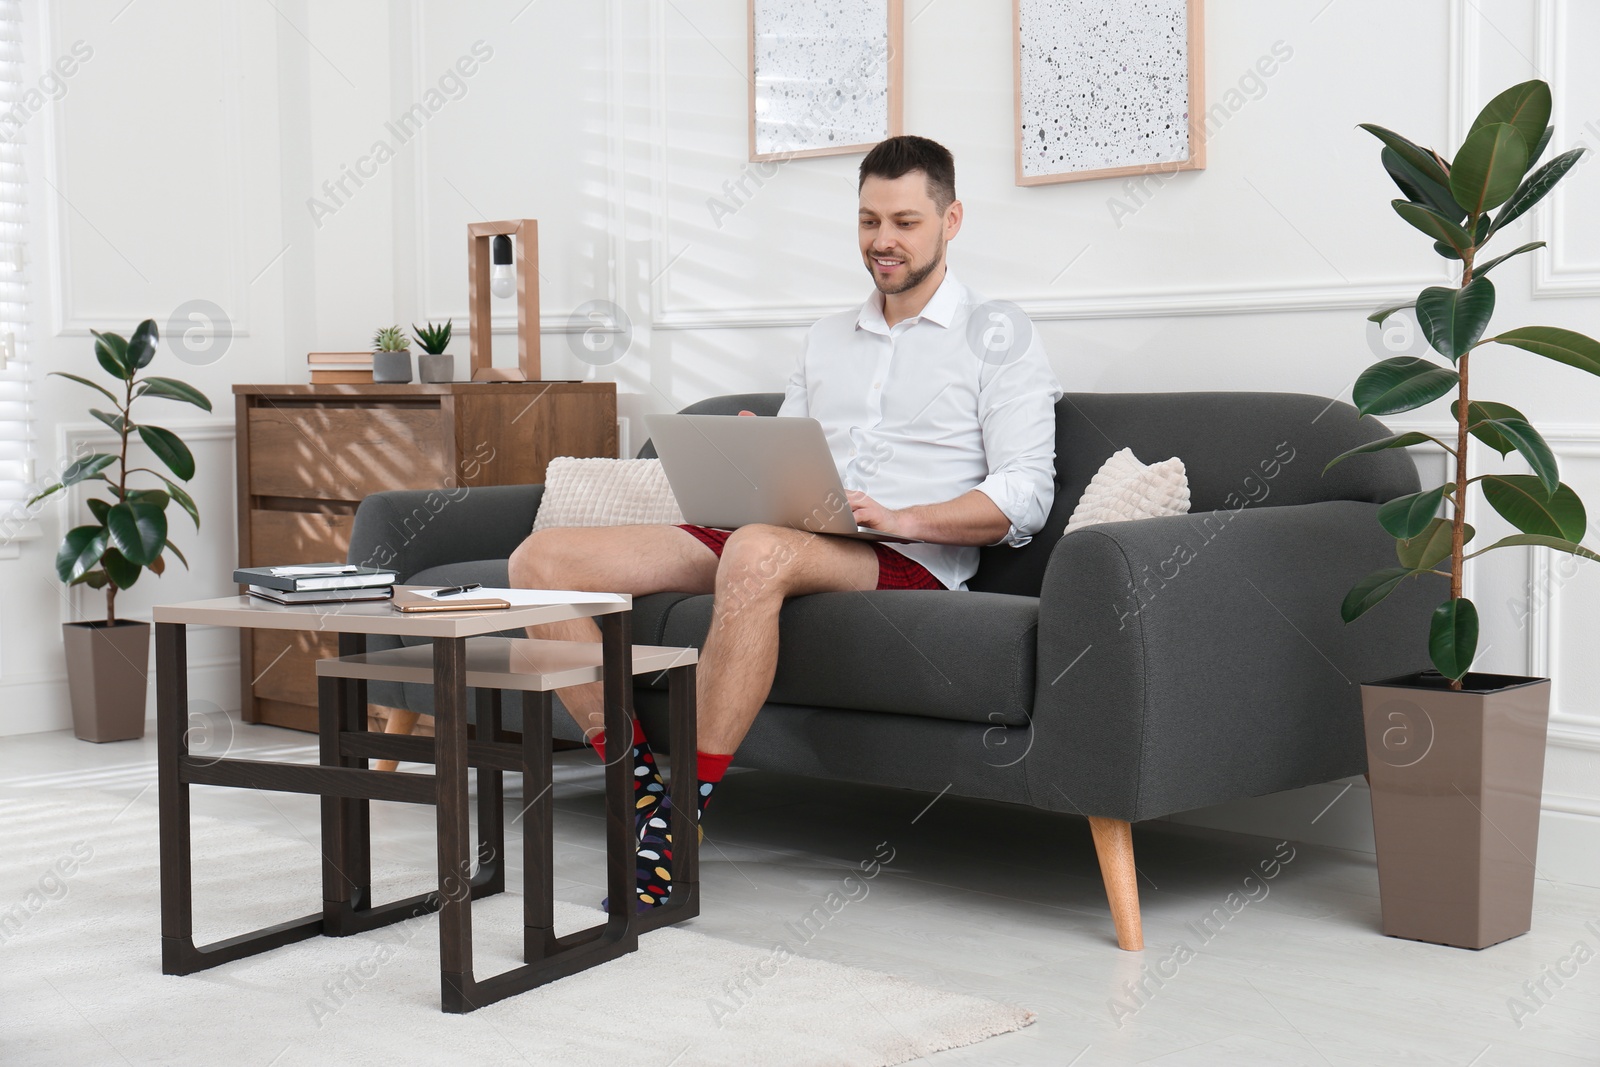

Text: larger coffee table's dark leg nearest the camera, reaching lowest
xmin=434 ymin=637 xmax=477 ymax=1014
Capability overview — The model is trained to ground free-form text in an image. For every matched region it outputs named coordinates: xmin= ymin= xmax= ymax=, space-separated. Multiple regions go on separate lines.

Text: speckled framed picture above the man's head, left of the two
xmin=747 ymin=0 xmax=906 ymax=163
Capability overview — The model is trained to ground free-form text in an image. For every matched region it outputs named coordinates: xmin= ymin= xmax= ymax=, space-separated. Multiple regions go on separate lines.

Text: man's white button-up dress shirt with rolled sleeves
xmin=778 ymin=270 xmax=1061 ymax=589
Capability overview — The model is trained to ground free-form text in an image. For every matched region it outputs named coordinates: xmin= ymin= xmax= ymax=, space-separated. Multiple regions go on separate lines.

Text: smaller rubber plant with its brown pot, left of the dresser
xmin=29 ymin=318 xmax=211 ymax=741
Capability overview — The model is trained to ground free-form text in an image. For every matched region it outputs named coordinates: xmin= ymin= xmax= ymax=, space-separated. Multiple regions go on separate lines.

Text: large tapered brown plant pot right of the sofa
xmin=1362 ymin=672 xmax=1550 ymax=949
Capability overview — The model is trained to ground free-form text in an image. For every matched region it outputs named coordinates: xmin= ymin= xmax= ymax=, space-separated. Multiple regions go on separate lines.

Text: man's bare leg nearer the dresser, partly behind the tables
xmin=510 ymin=526 xmax=717 ymax=737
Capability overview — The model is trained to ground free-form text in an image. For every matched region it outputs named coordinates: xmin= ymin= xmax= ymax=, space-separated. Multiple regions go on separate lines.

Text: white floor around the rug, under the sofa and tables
xmin=0 ymin=726 xmax=1600 ymax=1067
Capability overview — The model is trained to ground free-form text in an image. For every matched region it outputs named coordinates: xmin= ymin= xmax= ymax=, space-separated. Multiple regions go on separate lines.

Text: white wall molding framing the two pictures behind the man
xmin=650 ymin=0 xmax=1482 ymax=330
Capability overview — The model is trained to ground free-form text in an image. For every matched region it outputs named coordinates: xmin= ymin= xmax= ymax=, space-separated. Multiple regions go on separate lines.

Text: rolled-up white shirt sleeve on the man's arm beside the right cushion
xmin=966 ymin=333 xmax=1061 ymax=547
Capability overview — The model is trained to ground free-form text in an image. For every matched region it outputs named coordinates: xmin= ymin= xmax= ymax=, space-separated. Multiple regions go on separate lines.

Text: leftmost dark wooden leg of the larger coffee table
xmin=155 ymin=622 xmax=195 ymax=974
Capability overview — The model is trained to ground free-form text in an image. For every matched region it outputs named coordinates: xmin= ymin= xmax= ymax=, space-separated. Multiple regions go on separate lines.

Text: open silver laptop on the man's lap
xmin=645 ymin=414 xmax=912 ymax=544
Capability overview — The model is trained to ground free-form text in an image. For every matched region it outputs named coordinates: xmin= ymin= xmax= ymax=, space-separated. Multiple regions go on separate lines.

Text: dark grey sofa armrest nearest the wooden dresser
xmin=349 ymin=485 xmax=544 ymax=582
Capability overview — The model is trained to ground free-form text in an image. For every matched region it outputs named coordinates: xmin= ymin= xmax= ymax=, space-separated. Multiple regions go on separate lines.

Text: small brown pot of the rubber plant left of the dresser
xmin=61 ymin=621 xmax=150 ymax=742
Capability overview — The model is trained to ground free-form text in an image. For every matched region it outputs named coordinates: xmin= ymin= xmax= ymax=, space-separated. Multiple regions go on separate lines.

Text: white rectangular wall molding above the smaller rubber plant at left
xmin=35 ymin=5 xmax=250 ymax=338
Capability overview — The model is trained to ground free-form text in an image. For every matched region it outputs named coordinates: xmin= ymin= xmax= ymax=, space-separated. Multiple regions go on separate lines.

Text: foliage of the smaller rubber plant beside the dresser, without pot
xmin=29 ymin=318 xmax=211 ymax=624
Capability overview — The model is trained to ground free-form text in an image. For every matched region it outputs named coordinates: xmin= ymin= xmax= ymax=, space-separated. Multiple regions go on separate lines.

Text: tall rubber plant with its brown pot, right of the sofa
xmin=1328 ymin=80 xmax=1600 ymax=949
